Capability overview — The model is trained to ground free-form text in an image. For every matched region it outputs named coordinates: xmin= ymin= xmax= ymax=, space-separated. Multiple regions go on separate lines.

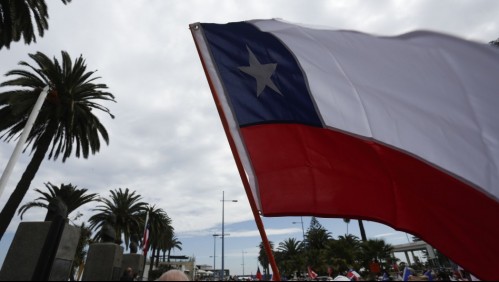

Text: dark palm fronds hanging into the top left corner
xmin=0 ymin=0 xmax=71 ymax=49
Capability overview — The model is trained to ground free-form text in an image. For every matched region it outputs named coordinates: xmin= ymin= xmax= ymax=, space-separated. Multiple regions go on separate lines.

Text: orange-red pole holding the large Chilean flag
xmin=190 ymin=24 xmax=281 ymax=281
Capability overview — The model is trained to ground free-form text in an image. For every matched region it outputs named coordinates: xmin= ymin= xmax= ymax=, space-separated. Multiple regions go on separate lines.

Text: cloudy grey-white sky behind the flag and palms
xmin=0 ymin=0 xmax=499 ymax=274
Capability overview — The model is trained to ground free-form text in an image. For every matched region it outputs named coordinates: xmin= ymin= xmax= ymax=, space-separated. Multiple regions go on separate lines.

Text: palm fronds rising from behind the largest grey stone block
xmin=18 ymin=182 xmax=97 ymax=219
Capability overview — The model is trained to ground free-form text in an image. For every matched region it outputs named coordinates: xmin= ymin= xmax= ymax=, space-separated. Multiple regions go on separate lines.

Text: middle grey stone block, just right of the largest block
xmin=82 ymin=243 xmax=123 ymax=281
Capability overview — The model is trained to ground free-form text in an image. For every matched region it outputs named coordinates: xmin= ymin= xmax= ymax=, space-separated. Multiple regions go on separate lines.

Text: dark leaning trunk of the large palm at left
xmin=0 ymin=125 xmax=54 ymax=240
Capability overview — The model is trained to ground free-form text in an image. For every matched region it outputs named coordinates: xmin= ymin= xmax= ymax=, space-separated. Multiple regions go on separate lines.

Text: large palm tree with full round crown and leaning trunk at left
xmin=0 ymin=51 xmax=115 ymax=240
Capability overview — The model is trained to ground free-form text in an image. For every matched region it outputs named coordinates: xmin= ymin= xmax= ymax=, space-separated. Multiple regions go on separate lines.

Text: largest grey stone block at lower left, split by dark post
xmin=0 ymin=221 xmax=80 ymax=281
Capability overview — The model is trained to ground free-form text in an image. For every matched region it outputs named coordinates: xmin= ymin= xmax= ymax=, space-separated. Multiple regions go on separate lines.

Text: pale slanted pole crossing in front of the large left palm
xmin=0 ymin=85 xmax=49 ymax=197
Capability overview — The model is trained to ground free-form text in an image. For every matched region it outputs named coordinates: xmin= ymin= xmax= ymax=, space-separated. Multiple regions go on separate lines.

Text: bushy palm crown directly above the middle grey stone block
xmin=89 ymin=188 xmax=147 ymax=250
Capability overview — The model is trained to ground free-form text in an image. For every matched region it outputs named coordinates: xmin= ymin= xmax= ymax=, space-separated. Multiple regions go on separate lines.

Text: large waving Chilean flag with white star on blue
xmin=191 ymin=20 xmax=499 ymax=280
